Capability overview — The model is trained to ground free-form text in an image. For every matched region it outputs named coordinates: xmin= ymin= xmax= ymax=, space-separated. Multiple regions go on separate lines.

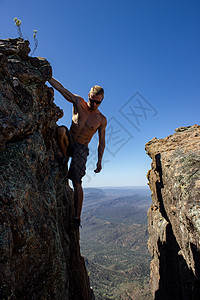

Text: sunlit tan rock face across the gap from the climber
xmin=146 ymin=125 xmax=200 ymax=300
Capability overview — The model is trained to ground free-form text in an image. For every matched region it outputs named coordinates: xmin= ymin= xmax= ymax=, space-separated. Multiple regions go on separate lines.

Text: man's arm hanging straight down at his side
xmin=94 ymin=118 xmax=107 ymax=173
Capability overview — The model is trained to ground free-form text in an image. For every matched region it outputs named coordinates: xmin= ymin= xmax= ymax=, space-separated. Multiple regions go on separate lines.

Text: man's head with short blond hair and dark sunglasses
xmin=88 ymin=85 xmax=104 ymax=110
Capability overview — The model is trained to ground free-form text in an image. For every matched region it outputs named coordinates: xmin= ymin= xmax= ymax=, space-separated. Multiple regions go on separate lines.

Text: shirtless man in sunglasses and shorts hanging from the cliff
xmin=49 ymin=78 xmax=107 ymax=227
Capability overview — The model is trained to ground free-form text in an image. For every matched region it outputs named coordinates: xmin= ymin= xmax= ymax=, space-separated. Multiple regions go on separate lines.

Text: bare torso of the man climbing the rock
xmin=70 ymin=99 xmax=106 ymax=145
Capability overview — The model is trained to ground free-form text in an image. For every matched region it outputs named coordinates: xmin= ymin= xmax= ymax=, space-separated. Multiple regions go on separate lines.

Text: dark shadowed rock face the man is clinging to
xmin=0 ymin=39 xmax=91 ymax=300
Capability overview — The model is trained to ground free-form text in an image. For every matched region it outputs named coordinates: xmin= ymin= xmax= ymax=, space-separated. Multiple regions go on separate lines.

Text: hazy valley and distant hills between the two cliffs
xmin=81 ymin=188 xmax=152 ymax=300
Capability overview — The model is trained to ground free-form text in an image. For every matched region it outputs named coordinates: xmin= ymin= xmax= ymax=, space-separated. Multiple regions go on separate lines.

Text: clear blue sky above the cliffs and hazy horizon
xmin=0 ymin=0 xmax=200 ymax=187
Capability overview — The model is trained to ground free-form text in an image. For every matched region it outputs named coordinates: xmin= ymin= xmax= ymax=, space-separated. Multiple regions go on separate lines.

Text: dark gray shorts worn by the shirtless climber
xmin=67 ymin=142 xmax=89 ymax=184
